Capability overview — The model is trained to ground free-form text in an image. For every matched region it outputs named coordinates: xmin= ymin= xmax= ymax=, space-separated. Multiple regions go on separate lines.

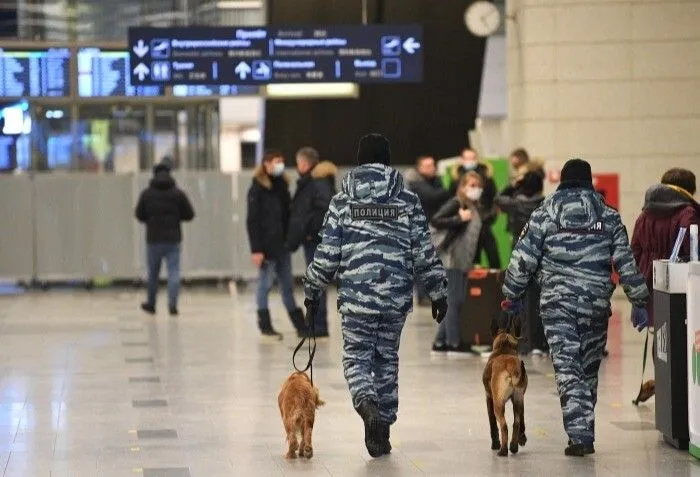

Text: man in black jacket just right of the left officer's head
xmin=404 ymin=155 xmax=454 ymax=307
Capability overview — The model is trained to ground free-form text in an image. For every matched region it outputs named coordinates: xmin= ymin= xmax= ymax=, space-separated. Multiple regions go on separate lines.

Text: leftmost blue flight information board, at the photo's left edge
xmin=0 ymin=48 xmax=70 ymax=98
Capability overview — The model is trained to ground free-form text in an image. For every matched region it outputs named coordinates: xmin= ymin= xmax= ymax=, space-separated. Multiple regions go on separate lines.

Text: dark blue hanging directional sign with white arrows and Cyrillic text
xmin=129 ymin=25 xmax=423 ymax=86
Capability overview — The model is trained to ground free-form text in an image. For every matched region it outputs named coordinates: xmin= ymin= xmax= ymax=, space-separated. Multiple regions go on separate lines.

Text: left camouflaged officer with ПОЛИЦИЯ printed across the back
xmin=305 ymin=134 xmax=447 ymax=457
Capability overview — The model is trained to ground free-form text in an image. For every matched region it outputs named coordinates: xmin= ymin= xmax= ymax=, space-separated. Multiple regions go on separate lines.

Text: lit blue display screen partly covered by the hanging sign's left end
xmin=78 ymin=48 xmax=164 ymax=98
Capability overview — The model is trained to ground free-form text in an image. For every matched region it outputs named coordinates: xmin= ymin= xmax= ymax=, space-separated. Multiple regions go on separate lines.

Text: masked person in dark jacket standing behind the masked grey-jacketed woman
xmin=443 ymin=148 xmax=501 ymax=269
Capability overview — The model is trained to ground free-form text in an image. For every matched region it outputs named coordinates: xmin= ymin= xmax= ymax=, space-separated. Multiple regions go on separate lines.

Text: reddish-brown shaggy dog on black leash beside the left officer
xmin=277 ymin=372 xmax=325 ymax=459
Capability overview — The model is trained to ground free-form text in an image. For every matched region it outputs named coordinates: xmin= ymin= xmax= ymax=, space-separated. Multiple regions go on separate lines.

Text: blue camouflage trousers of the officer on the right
xmin=542 ymin=304 xmax=608 ymax=444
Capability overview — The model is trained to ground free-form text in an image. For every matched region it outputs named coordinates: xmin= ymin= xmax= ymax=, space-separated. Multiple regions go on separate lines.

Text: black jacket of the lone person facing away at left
xmin=135 ymin=165 xmax=194 ymax=244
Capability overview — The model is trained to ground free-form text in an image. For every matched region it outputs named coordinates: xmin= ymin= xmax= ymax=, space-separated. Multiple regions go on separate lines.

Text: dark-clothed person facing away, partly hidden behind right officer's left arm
xmin=495 ymin=167 xmax=549 ymax=356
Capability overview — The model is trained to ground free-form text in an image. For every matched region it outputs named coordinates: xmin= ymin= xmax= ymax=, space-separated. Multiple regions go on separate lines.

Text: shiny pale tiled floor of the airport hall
xmin=0 ymin=291 xmax=700 ymax=477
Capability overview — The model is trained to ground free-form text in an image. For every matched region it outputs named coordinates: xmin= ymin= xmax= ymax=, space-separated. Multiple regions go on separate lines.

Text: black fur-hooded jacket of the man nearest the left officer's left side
xmin=287 ymin=161 xmax=338 ymax=251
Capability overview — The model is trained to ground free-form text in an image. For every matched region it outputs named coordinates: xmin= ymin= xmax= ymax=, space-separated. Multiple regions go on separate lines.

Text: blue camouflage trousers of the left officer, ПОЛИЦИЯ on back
xmin=342 ymin=315 xmax=406 ymax=424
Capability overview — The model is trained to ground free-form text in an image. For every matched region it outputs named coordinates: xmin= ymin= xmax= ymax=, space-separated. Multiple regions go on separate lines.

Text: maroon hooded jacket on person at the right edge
xmin=632 ymin=184 xmax=700 ymax=289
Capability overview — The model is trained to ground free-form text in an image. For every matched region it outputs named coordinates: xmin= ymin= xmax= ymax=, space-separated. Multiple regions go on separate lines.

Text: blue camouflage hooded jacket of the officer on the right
xmin=503 ymin=184 xmax=649 ymax=319
